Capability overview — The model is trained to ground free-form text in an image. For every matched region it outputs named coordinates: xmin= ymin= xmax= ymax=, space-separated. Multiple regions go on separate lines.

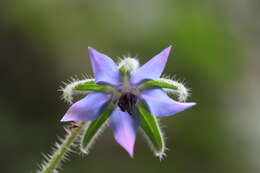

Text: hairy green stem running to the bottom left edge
xmin=41 ymin=122 xmax=85 ymax=173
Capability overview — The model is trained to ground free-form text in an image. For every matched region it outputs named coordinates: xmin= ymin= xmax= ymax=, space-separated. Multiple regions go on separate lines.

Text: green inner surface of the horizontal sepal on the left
xmin=74 ymin=81 xmax=112 ymax=91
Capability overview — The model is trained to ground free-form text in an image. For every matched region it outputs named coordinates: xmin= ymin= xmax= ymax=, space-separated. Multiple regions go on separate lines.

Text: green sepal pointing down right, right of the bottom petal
xmin=136 ymin=102 xmax=165 ymax=158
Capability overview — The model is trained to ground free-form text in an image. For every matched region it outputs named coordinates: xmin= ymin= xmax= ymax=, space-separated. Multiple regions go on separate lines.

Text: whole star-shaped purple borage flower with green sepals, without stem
xmin=61 ymin=46 xmax=195 ymax=157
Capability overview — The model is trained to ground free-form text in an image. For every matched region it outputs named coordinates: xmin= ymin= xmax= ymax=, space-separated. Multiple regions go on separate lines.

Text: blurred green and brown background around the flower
xmin=0 ymin=0 xmax=260 ymax=173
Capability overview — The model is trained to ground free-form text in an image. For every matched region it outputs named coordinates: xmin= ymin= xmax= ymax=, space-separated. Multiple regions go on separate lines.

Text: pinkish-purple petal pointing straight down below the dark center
xmin=109 ymin=107 xmax=139 ymax=157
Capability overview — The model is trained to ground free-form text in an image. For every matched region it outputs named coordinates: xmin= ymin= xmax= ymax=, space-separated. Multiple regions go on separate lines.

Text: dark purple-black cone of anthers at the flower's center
xmin=118 ymin=92 xmax=138 ymax=115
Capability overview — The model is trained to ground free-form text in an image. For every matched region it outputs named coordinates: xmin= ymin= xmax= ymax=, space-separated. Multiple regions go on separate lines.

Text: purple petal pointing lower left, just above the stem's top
xmin=61 ymin=92 xmax=110 ymax=121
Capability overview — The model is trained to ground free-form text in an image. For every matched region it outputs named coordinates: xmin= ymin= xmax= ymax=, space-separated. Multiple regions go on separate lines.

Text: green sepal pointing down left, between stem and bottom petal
xmin=80 ymin=103 xmax=115 ymax=154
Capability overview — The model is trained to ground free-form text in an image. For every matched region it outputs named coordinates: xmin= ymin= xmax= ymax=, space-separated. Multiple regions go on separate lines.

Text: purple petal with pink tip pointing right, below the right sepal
xmin=141 ymin=89 xmax=196 ymax=117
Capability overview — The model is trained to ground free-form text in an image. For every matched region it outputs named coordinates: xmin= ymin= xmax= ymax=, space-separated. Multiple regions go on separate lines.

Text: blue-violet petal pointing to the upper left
xmin=89 ymin=47 xmax=120 ymax=86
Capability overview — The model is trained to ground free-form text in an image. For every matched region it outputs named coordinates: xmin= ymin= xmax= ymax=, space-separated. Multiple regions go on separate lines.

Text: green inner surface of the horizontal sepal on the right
xmin=138 ymin=80 xmax=178 ymax=90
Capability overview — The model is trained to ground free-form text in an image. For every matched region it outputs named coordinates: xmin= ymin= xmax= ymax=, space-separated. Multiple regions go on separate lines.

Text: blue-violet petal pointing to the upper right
xmin=131 ymin=46 xmax=171 ymax=84
